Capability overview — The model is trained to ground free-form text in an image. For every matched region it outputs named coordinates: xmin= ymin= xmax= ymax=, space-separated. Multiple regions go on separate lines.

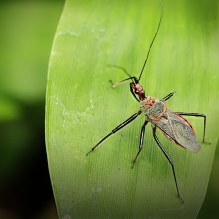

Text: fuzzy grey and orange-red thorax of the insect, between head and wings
xmin=140 ymin=96 xmax=167 ymax=120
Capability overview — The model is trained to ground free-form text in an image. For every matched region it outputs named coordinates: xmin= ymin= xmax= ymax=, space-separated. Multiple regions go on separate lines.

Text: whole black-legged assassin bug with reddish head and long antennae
xmin=86 ymin=7 xmax=207 ymax=203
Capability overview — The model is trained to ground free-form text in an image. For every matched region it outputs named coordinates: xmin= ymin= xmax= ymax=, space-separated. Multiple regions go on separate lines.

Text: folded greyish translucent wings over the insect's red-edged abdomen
xmin=152 ymin=110 xmax=201 ymax=152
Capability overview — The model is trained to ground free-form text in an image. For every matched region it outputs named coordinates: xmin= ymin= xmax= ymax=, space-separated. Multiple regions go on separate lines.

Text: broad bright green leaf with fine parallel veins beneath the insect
xmin=46 ymin=0 xmax=219 ymax=218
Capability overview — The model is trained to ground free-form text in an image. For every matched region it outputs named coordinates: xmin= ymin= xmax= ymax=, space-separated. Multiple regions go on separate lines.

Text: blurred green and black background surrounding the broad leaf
xmin=0 ymin=0 xmax=219 ymax=219
